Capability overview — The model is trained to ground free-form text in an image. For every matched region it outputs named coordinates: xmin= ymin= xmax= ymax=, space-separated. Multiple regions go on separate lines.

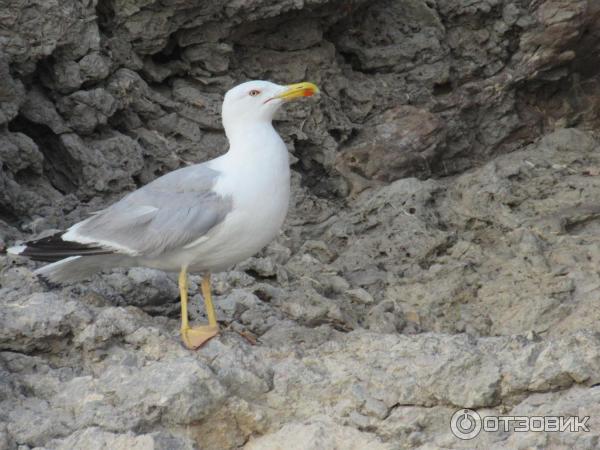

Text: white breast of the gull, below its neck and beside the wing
xmin=190 ymin=127 xmax=290 ymax=271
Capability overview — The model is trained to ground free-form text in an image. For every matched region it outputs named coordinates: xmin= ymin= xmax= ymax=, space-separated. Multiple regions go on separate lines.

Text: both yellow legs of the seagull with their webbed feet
xmin=179 ymin=267 xmax=219 ymax=350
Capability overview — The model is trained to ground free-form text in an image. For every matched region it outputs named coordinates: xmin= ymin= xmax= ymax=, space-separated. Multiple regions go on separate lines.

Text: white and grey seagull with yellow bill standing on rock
xmin=7 ymin=81 xmax=319 ymax=349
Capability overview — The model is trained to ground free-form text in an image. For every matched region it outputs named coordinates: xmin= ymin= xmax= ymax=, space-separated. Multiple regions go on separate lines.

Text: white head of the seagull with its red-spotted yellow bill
xmin=222 ymin=80 xmax=319 ymax=130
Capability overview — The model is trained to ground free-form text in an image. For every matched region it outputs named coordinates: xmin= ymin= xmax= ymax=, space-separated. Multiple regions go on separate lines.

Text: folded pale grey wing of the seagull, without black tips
xmin=62 ymin=164 xmax=231 ymax=257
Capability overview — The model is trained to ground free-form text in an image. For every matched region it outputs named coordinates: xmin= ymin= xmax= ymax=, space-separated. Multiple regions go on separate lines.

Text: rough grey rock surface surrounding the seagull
xmin=0 ymin=0 xmax=600 ymax=450
